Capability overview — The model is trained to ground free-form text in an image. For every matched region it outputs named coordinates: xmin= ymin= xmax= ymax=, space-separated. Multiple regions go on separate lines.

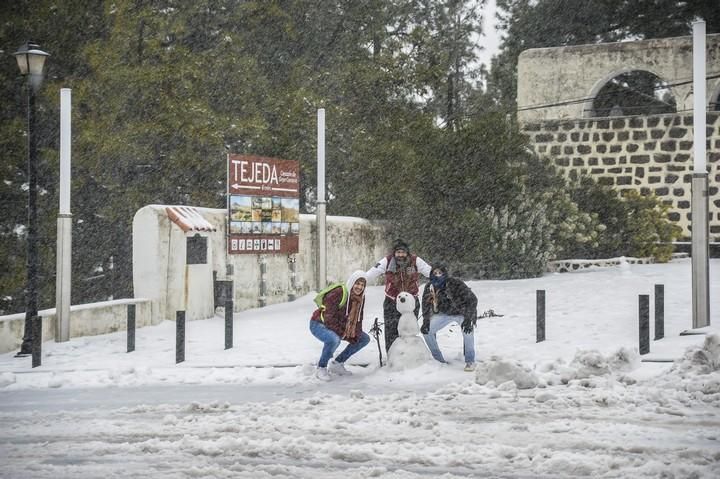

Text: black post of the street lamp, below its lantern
xmin=17 ymin=82 xmax=39 ymax=356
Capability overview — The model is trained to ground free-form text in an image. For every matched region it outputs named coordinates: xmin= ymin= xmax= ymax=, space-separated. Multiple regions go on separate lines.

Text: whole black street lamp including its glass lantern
xmin=14 ymin=42 xmax=49 ymax=357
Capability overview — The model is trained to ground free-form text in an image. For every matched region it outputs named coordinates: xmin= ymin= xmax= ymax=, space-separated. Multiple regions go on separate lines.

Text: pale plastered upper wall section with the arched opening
xmin=517 ymin=34 xmax=720 ymax=122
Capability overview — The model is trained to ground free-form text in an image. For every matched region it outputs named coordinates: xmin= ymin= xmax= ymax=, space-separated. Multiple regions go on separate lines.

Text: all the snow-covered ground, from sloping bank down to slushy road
xmin=0 ymin=259 xmax=720 ymax=479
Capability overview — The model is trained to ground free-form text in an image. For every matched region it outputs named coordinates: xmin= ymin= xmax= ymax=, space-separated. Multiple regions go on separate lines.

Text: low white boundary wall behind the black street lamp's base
xmin=0 ymin=298 xmax=152 ymax=353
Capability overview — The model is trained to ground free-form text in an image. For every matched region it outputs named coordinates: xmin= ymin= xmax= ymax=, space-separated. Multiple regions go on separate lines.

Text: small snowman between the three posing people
xmin=388 ymin=293 xmax=431 ymax=369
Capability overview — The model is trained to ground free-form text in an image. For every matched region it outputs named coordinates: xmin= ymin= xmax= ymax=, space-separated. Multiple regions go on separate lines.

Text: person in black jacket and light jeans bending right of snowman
xmin=420 ymin=264 xmax=477 ymax=371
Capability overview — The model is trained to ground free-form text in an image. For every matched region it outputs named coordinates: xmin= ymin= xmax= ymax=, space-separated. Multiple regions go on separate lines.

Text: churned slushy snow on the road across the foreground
xmin=0 ymin=354 xmax=720 ymax=479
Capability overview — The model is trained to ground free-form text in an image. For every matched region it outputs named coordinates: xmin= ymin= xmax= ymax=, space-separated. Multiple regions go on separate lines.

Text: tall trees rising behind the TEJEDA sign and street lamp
xmin=0 ymin=0 xmax=490 ymax=312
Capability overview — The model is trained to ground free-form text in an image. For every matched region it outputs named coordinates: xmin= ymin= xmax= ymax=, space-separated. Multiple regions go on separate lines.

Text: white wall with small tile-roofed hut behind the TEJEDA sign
xmin=133 ymin=205 xmax=391 ymax=320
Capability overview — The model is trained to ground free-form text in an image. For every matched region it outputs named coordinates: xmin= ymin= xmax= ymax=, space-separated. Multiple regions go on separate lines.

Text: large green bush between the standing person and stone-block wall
xmin=397 ymin=124 xmax=604 ymax=279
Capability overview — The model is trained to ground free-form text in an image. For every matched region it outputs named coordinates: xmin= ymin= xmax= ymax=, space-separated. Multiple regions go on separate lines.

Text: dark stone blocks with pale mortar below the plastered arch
xmin=522 ymin=112 xmax=720 ymax=241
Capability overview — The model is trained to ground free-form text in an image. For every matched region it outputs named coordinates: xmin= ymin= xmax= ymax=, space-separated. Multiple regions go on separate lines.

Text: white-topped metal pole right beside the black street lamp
xmin=55 ymin=88 xmax=72 ymax=342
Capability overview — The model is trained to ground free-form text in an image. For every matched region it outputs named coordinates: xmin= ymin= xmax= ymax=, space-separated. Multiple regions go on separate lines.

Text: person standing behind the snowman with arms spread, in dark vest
xmin=365 ymin=239 xmax=430 ymax=351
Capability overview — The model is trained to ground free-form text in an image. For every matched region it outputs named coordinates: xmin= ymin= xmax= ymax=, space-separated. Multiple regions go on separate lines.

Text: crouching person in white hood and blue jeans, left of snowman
xmin=310 ymin=271 xmax=370 ymax=381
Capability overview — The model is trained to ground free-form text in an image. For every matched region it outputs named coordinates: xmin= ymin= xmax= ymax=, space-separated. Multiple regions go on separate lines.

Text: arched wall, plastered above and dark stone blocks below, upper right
xmin=517 ymin=34 xmax=720 ymax=241
